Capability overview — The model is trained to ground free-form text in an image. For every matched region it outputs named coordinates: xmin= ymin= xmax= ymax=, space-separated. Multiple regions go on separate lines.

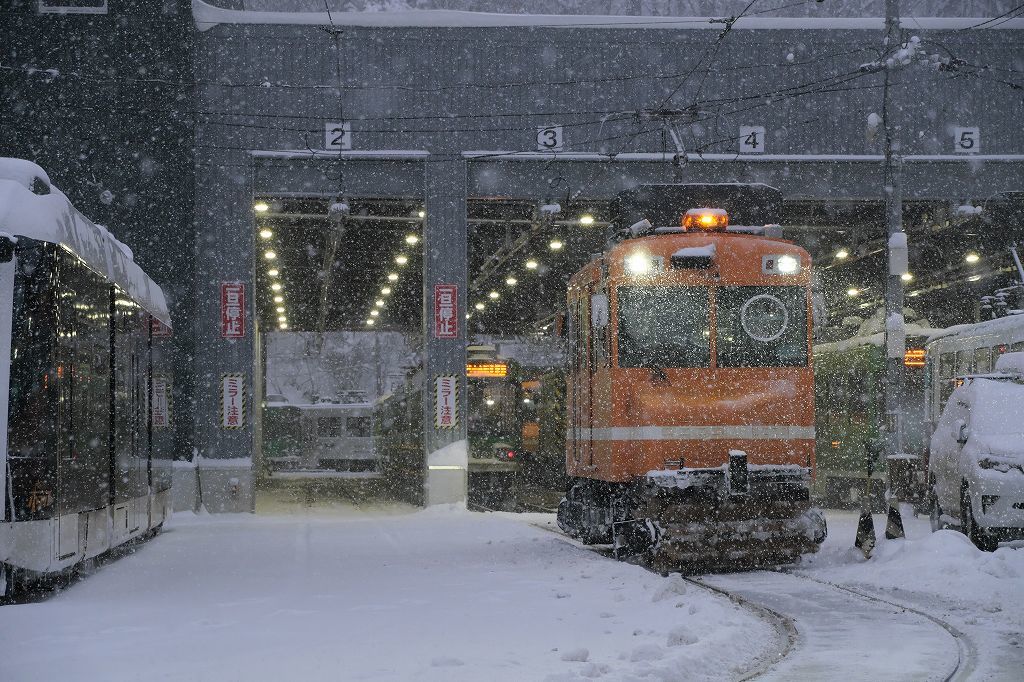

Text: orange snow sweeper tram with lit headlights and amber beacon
xmin=558 ymin=184 xmax=825 ymax=566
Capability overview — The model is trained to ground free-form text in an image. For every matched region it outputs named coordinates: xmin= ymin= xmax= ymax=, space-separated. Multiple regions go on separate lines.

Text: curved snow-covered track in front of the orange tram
xmin=531 ymin=516 xmax=977 ymax=682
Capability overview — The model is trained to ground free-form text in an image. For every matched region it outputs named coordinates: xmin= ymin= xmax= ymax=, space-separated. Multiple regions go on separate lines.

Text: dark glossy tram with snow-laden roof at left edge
xmin=0 ymin=159 xmax=172 ymax=597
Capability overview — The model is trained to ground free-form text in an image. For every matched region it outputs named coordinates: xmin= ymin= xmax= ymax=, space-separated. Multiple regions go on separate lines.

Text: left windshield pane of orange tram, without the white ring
xmin=617 ymin=287 xmax=711 ymax=368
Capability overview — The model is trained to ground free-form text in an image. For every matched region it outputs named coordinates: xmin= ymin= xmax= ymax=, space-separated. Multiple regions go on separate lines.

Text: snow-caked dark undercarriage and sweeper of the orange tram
xmin=558 ymin=457 xmax=826 ymax=568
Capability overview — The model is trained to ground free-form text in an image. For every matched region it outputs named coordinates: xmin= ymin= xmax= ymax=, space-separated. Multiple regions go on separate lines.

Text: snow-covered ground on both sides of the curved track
xmin=0 ymin=507 xmax=1024 ymax=681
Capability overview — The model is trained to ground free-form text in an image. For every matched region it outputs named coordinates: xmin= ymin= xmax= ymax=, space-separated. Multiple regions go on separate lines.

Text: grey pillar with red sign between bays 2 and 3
xmin=423 ymin=158 xmax=468 ymax=506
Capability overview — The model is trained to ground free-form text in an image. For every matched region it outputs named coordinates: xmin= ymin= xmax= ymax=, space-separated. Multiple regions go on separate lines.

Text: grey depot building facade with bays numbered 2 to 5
xmin=0 ymin=0 xmax=1024 ymax=511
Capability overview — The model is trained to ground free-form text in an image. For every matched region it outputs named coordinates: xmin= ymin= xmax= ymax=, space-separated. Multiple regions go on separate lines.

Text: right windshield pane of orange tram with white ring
xmin=717 ymin=287 xmax=808 ymax=367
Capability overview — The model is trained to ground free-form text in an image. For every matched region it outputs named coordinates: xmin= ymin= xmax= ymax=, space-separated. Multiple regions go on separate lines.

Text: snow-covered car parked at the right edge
xmin=928 ymin=352 xmax=1024 ymax=551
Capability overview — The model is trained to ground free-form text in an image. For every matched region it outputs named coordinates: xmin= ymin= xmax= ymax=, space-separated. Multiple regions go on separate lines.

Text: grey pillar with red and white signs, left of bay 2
xmin=193 ymin=155 xmax=256 ymax=512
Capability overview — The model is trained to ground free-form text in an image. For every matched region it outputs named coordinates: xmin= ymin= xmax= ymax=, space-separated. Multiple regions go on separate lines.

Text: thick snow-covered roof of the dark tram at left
xmin=0 ymin=164 xmax=171 ymax=326
